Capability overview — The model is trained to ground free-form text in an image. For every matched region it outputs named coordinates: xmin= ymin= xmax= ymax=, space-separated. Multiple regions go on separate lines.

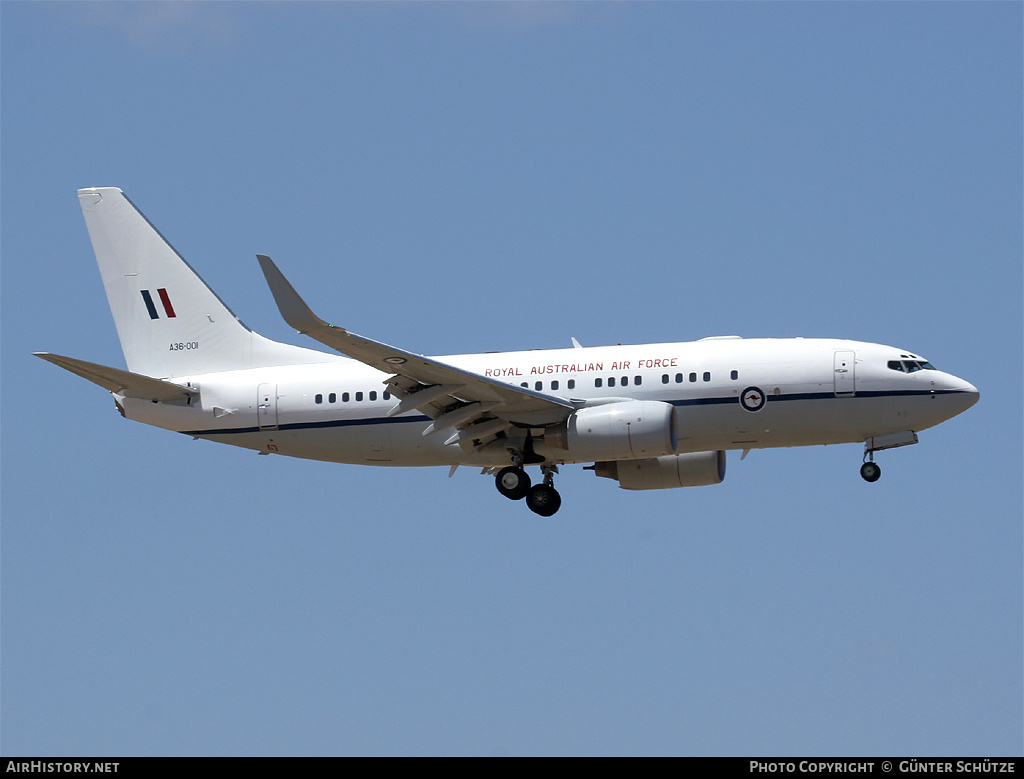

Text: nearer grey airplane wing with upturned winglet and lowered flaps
xmin=257 ymin=255 xmax=577 ymax=442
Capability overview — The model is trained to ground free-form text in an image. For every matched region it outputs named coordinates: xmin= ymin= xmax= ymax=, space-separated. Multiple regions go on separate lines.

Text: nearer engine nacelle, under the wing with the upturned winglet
xmin=544 ymin=400 xmax=679 ymax=461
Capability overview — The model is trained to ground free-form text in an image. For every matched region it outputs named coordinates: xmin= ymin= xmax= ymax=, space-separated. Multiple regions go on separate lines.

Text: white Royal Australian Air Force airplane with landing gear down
xmin=37 ymin=187 xmax=978 ymax=516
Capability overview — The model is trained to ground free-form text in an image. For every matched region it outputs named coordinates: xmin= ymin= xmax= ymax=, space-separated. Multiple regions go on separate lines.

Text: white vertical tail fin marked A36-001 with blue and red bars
xmin=78 ymin=187 xmax=331 ymax=378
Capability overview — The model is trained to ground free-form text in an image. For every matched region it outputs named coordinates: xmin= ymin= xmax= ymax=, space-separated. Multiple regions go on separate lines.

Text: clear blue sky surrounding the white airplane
xmin=0 ymin=2 xmax=1024 ymax=755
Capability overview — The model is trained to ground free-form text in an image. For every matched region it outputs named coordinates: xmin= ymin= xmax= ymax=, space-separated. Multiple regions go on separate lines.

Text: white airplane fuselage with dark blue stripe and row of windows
xmin=120 ymin=338 xmax=977 ymax=467
